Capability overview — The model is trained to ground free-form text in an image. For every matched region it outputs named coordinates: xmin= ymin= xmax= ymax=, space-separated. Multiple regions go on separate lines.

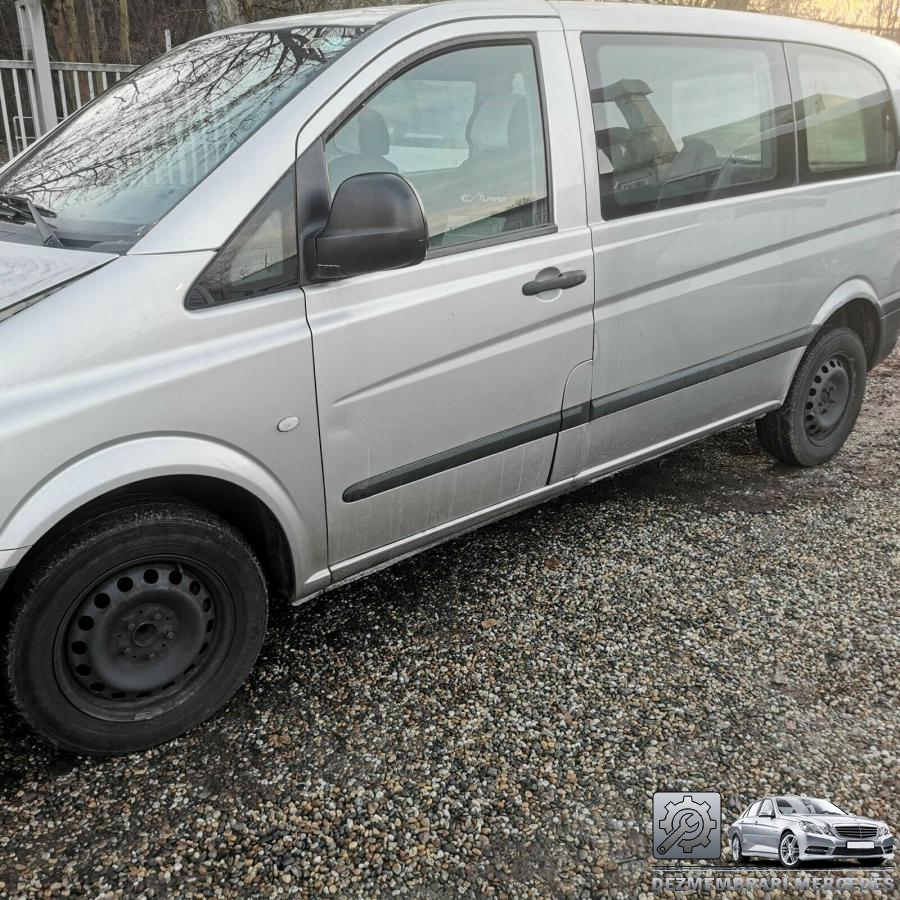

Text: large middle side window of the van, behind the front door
xmin=582 ymin=34 xmax=795 ymax=219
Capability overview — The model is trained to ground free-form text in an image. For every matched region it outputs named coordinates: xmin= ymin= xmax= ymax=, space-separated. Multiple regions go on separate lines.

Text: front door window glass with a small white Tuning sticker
xmin=325 ymin=43 xmax=550 ymax=248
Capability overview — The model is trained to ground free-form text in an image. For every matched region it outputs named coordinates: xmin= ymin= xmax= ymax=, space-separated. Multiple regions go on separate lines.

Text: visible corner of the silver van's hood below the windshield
xmin=0 ymin=241 xmax=117 ymax=319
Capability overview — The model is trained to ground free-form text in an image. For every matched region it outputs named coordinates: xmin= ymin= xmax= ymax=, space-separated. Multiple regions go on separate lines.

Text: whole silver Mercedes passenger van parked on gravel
xmin=0 ymin=0 xmax=900 ymax=754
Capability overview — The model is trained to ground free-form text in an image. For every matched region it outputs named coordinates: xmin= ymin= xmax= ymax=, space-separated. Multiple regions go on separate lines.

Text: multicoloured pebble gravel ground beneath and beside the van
xmin=0 ymin=354 xmax=900 ymax=898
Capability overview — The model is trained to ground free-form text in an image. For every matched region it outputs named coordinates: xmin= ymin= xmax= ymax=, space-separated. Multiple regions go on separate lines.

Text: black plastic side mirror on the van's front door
xmin=307 ymin=172 xmax=428 ymax=281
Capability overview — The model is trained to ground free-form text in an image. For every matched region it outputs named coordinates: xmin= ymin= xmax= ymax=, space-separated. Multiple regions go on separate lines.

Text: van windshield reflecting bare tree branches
xmin=0 ymin=25 xmax=367 ymax=250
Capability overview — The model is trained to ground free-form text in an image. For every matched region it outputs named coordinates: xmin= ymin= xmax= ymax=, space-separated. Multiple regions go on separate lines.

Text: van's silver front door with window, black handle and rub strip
xmin=306 ymin=33 xmax=593 ymax=575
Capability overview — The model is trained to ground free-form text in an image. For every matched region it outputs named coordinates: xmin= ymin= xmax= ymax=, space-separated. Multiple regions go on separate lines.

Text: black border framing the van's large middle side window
xmin=578 ymin=30 xmax=799 ymax=224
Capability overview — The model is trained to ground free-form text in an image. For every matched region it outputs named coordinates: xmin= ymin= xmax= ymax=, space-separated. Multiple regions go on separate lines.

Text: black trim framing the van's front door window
xmin=297 ymin=31 xmax=559 ymax=274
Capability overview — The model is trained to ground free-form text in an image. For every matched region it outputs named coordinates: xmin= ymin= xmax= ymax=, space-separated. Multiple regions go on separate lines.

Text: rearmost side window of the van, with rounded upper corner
xmin=787 ymin=44 xmax=897 ymax=181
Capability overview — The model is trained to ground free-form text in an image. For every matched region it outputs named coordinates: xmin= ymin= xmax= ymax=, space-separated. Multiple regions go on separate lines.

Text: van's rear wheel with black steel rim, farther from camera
xmin=756 ymin=328 xmax=867 ymax=466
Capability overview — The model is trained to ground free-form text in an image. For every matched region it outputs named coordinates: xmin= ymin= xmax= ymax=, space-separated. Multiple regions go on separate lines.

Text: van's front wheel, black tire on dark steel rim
xmin=4 ymin=500 xmax=267 ymax=756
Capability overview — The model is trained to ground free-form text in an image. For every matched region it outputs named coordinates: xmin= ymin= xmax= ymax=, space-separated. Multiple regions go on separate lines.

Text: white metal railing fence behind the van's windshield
xmin=0 ymin=59 xmax=135 ymax=161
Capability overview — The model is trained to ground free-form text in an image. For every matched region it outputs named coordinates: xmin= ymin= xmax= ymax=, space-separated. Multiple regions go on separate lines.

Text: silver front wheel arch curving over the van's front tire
xmin=0 ymin=436 xmax=328 ymax=599
